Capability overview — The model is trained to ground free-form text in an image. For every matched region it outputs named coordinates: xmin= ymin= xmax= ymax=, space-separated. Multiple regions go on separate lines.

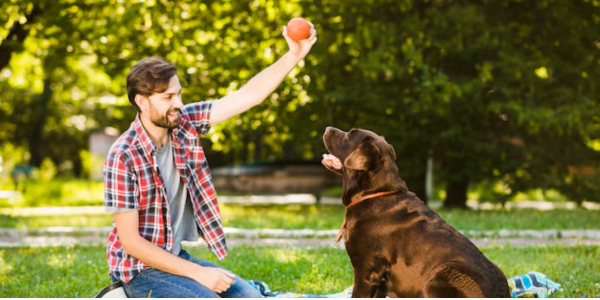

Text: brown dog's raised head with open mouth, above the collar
xmin=323 ymin=127 xmax=407 ymax=205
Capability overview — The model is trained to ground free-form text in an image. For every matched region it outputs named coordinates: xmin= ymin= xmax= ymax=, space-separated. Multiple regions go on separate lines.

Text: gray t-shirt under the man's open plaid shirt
xmin=106 ymin=136 xmax=198 ymax=255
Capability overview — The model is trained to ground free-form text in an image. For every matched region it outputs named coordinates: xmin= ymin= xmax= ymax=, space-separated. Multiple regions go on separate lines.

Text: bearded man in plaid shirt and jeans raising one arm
xmin=104 ymin=27 xmax=317 ymax=298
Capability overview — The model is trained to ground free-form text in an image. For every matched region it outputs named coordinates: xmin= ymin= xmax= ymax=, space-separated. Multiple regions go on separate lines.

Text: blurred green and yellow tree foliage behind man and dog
xmin=0 ymin=0 xmax=600 ymax=208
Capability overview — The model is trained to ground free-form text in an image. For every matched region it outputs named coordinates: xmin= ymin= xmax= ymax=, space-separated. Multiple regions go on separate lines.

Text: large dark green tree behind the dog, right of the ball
xmin=300 ymin=1 xmax=599 ymax=208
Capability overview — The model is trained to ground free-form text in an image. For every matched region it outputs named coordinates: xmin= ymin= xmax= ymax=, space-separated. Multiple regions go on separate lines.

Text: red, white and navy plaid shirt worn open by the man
xmin=104 ymin=101 xmax=227 ymax=283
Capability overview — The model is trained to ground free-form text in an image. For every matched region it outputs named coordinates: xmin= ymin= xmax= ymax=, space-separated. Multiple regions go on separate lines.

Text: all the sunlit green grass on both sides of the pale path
xmin=0 ymin=199 xmax=600 ymax=298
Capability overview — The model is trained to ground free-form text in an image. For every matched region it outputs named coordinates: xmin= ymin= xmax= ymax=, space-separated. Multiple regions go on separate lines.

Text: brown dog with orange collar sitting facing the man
xmin=323 ymin=127 xmax=510 ymax=298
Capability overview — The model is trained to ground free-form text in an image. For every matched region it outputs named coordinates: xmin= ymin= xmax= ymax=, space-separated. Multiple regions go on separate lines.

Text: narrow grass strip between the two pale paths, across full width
xmin=0 ymin=205 xmax=600 ymax=230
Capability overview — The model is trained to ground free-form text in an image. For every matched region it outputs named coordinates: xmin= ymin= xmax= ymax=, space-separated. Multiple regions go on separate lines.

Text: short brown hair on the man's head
xmin=127 ymin=56 xmax=177 ymax=111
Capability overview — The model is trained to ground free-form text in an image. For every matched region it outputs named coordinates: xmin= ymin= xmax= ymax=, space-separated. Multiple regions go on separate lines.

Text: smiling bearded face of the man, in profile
xmin=148 ymin=75 xmax=183 ymax=129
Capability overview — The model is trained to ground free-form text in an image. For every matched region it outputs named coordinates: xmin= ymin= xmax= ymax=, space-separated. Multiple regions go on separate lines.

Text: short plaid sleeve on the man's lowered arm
xmin=104 ymin=153 xmax=139 ymax=212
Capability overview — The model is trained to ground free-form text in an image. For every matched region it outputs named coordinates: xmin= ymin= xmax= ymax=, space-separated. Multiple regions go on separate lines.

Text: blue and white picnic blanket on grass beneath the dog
xmin=248 ymin=272 xmax=561 ymax=298
